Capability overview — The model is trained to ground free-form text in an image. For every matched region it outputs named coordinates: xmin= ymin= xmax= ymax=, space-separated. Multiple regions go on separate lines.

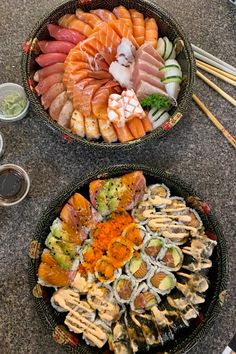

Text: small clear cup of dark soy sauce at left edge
xmin=0 ymin=164 xmax=30 ymax=206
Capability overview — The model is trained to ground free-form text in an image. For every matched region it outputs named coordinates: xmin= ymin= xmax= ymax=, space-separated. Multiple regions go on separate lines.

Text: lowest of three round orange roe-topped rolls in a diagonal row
xmin=95 ymin=256 xmax=121 ymax=284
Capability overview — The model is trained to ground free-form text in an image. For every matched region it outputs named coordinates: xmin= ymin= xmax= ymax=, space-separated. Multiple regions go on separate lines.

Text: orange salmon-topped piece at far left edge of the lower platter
xmin=38 ymin=249 xmax=75 ymax=286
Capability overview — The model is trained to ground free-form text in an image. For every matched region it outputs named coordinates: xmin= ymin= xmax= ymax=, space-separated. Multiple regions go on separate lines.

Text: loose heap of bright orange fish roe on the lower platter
xmin=79 ymin=212 xmax=134 ymax=275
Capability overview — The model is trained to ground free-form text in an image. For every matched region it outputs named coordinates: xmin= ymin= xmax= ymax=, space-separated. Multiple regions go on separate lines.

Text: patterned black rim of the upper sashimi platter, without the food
xmin=21 ymin=0 xmax=195 ymax=151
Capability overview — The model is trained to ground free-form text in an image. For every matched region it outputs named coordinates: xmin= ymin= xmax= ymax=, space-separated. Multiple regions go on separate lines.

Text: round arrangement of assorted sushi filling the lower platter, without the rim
xmin=38 ymin=171 xmax=217 ymax=354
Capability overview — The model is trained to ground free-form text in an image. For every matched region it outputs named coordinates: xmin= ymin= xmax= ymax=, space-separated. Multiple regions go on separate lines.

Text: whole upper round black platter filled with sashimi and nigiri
xmin=22 ymin=1 xmax=195 ymax=147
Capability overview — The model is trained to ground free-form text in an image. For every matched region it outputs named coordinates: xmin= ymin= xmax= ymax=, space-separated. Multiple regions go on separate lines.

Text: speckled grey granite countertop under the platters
xmin=0 ymin=0 xmax=236 ymax=354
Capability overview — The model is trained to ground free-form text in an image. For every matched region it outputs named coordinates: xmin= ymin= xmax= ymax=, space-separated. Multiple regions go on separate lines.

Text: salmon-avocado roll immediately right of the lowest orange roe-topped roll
xmin=125 ymin=253 xmax=149 ymax=282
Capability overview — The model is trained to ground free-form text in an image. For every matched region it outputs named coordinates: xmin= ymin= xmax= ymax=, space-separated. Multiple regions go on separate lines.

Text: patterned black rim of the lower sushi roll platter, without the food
xmin=29 ymin=164 xmax=228 ymax=354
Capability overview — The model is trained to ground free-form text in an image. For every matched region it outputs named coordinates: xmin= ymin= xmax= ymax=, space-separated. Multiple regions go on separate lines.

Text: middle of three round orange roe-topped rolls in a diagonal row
xmin=107 ymin=237 xmax=133 ymax=268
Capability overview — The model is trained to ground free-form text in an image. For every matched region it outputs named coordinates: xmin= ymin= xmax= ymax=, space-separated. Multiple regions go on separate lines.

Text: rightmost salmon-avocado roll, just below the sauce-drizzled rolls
xmin=158 ymin=245 xmax=183 ymax=271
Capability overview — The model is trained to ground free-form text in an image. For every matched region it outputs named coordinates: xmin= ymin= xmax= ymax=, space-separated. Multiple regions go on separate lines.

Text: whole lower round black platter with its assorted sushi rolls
xmin=30 ymin=165 xmax=227 ymax=354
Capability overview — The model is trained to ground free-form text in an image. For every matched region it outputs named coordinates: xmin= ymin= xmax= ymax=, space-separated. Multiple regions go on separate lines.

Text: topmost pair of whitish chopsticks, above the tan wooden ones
xmin=191 ymin=43 xmax=236 ymax=75
